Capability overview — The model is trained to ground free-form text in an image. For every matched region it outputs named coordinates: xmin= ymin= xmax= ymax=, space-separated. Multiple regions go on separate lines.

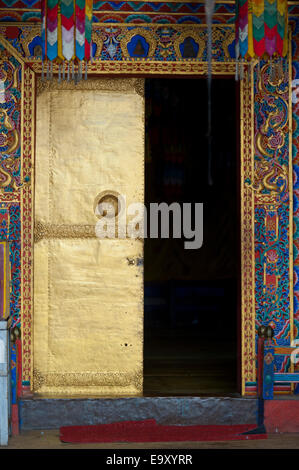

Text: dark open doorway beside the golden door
xmin=144 ymin=78 xmax=240 ymax=396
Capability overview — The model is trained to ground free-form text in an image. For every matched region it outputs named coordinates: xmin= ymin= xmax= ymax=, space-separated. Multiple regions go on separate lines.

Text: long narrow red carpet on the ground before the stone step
xmin=60 ymin=419 xmax=267 ymax=443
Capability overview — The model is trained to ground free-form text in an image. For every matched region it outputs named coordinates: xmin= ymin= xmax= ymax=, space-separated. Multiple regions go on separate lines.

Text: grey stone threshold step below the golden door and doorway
xmin=20 ymin=397 xmax=257 ymax=431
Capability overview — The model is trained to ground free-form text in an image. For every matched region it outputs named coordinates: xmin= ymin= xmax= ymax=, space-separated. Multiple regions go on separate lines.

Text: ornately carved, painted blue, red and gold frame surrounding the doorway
xmin=0 ymin=23 xmax=294 ymax=396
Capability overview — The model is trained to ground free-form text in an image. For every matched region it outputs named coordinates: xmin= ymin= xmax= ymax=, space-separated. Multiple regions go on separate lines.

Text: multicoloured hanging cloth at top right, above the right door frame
xmin=236 ymin=0 xmax=288 ymax=59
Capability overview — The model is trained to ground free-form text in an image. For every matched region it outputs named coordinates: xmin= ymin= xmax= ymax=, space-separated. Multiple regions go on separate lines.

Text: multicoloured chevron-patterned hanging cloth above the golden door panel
xmin=41 ymin=0 xmax=92 ymax=62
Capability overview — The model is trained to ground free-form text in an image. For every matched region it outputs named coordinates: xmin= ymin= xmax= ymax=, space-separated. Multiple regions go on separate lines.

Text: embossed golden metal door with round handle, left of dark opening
xmin=33 ymin=78 xmax=144 ymax=397
